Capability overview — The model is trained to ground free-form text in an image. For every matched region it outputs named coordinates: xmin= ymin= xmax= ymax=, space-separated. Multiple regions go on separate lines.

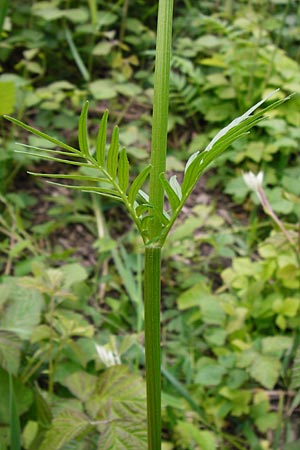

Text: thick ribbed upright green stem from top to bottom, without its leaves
xmin=144 ymin=0 xmax=174 ymax=450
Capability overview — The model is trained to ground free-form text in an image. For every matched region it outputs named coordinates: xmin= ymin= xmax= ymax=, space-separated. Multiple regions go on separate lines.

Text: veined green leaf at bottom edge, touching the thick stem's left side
xmin=97 ymin=418 xmax=148 ymax=450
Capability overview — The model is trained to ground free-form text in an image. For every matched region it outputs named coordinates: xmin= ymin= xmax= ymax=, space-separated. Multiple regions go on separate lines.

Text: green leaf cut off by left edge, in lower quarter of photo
xmin=0 ymin=328 xmax=22 ymax=375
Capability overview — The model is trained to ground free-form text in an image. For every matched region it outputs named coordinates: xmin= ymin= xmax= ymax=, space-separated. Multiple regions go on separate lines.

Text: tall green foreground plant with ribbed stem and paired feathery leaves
xmin=5 ymin=0 xmax=292 ymax=450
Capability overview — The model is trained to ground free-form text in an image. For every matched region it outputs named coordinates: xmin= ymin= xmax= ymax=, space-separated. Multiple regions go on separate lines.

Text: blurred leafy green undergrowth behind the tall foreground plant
xmin=0 ymin=0 xmax=300 ymax=450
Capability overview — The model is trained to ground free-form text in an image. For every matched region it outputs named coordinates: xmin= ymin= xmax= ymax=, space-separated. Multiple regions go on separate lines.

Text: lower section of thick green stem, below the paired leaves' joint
xmin=144 ymin=247 xmax=161 ymax=450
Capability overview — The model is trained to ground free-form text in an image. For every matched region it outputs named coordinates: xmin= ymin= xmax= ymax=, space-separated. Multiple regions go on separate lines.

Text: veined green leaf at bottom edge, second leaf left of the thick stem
xmin=39 ymin=410 xmax=93 ymax=450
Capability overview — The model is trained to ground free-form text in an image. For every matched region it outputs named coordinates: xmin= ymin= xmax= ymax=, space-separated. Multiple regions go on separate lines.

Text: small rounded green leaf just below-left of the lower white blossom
xmin=63 ymin=371 xmax=97 ymax=402
